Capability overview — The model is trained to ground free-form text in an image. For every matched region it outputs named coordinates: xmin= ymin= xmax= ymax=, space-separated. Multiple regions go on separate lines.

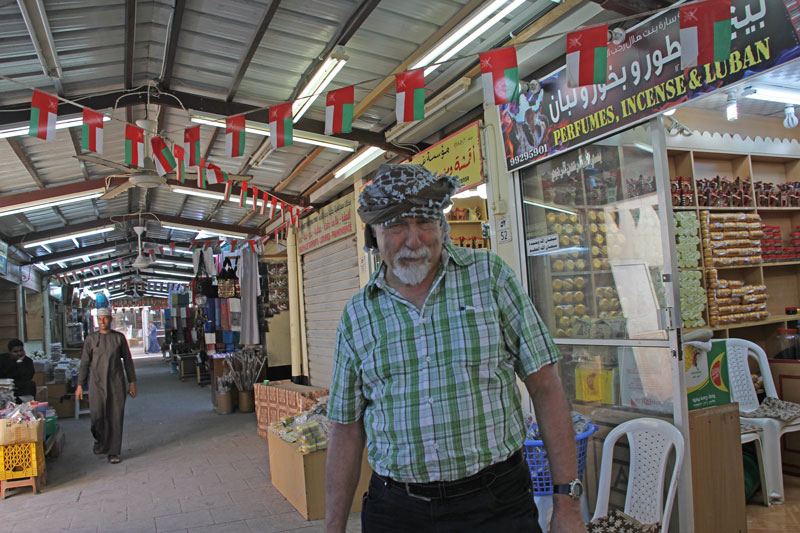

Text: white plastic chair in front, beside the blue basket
xmin=592 ymin=418 xmax=684 ymax=533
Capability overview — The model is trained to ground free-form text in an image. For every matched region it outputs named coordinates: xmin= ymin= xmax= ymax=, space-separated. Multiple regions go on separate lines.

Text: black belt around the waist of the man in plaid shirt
xmin=373 ymin=450 xmax=523 ymax=501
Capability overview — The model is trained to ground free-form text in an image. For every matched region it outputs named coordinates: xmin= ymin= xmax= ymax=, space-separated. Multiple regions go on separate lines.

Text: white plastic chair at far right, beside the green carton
xmin=713 ymin=339 xmax=800 ymax=502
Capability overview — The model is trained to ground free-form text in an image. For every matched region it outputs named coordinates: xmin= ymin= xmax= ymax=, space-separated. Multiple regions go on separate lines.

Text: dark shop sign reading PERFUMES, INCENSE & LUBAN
xmin=498 ymin=0 xmax=800 ymax=172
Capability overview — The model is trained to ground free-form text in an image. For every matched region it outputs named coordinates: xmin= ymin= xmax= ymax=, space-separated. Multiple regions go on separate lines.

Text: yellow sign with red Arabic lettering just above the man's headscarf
xmin=407 ymin=121 xmax=484 ymax=192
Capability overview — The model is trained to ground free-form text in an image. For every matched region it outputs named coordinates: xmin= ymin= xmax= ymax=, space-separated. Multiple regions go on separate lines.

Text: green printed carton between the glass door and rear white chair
xmin=683 ymin=342 xmax=731 ymax=411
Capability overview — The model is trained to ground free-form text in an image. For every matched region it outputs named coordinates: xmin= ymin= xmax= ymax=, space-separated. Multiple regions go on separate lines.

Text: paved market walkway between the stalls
xmin=0 ymin=356 xmax=360 ymax=533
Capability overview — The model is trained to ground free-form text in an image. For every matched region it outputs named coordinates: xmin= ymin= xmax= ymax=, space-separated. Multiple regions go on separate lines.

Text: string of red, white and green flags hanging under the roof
xmin=23 ymin=0 xmax=731 ymax=175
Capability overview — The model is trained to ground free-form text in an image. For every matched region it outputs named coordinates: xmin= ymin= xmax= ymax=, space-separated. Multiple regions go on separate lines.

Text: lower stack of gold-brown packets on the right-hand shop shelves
xmin=706 ymin=268 xmax=769 ymax=326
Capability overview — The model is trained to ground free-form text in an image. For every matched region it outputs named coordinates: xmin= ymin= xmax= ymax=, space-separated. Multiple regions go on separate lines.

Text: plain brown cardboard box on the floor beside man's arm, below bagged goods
xmin=267 ymin=433 xmax=372 ymax=520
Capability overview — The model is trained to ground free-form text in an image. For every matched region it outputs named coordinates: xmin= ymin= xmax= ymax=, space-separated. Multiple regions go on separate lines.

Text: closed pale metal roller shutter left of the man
xmin=303 ymin=237 xmax=359 ymax=387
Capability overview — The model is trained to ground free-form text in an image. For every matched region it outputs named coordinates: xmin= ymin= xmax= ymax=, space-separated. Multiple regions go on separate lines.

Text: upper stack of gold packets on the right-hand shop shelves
xmin=700 ymin=211 xmax=763 ymax=267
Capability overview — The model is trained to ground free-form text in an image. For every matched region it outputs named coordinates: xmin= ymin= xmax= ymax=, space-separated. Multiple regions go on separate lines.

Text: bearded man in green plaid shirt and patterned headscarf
xmin=326 ymin=165 xmax=585 ymax=533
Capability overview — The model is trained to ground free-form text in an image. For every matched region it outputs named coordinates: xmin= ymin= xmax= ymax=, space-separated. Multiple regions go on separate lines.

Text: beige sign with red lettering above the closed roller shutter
xmin=297 ymin=193 xmax=356 ymax=254
